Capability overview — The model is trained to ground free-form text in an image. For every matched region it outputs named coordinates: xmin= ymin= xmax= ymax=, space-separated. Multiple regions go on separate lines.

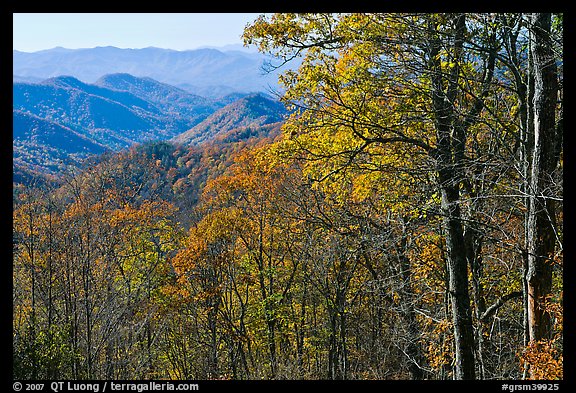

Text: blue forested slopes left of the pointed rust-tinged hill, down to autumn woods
xmin=12 ymin=75 xmax=212 ymax=180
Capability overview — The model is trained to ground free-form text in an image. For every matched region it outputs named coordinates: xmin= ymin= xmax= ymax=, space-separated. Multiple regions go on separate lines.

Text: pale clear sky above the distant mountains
xmin=13 ymin=13 xmax=259 ymax=52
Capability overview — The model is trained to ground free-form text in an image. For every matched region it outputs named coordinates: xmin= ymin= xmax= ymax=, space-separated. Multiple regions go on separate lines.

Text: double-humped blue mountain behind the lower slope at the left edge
xmin=13 ymin=75 xmax=222 ymax=150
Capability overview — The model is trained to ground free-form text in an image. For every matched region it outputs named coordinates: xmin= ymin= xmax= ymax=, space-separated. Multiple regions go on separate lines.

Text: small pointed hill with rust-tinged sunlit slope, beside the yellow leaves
xmin=172 ymin=93 xmax=287 ymax=144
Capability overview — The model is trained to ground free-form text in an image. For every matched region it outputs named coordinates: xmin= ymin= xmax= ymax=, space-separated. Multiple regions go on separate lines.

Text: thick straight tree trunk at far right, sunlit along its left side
xmin=526 ymin=13 xmax=558 ymax=342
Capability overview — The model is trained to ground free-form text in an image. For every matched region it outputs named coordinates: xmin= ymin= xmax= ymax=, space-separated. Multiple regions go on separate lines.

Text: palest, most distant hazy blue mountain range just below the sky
xmin=12 ymin=46 xmax=288 ymax=93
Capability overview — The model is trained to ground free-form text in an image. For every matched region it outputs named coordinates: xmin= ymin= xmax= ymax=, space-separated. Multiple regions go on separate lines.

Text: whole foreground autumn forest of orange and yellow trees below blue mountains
xmin=13 ymin=13 xmax=564 ymax=380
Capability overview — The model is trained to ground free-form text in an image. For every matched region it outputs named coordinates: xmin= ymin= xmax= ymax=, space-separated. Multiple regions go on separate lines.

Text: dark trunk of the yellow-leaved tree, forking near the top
xmin=429 ymin=14 xmax=476 ymax=379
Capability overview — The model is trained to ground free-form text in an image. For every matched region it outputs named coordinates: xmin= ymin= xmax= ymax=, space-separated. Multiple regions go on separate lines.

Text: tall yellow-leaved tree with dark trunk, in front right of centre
xmin=245 ymin=14 xmax=508 ymax=379
